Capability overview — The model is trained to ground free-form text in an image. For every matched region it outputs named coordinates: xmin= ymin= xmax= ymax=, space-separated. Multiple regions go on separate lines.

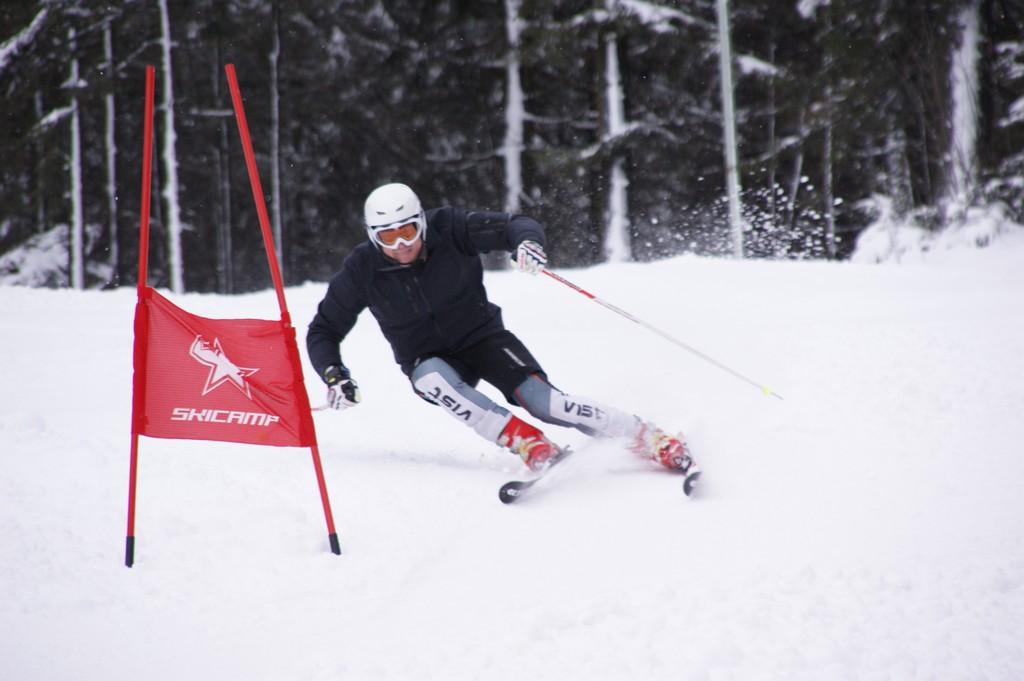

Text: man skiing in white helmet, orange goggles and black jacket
xmin=306 ymin=183 xmax=693 ymax=473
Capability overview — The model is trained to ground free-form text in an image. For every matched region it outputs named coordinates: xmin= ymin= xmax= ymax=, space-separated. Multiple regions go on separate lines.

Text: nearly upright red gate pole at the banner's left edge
xmin=125 ymin=66 xmax=156 ymax=567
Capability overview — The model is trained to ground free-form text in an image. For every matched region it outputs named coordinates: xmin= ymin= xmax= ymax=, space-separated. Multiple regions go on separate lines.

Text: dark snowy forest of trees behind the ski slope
xmin=0 ymin=0 xmax=1024 ymax=293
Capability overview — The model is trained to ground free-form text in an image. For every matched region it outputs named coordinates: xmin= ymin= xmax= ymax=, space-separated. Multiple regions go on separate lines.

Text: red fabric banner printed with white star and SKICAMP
xmin=133 ymin=288 xmax=316 ymax=446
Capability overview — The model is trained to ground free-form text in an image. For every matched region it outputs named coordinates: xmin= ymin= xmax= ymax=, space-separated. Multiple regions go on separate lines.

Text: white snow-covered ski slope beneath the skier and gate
xmin=0 ymin=233 xmax=1024 ymax=681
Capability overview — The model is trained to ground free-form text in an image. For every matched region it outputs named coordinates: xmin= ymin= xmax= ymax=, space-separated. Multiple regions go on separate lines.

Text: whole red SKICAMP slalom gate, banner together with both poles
xmin=125 ymin=65 xmax=341 ymax=567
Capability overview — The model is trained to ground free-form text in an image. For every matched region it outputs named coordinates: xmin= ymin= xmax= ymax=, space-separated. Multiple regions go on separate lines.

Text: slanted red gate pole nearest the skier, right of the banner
xmin=224 ymin=63 xmax=341 ymax=554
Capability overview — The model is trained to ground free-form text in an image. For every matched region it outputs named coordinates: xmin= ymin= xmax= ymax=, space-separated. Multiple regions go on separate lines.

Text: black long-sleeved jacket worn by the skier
xmin=306 ymin=207 xmax=545 ymax=377
